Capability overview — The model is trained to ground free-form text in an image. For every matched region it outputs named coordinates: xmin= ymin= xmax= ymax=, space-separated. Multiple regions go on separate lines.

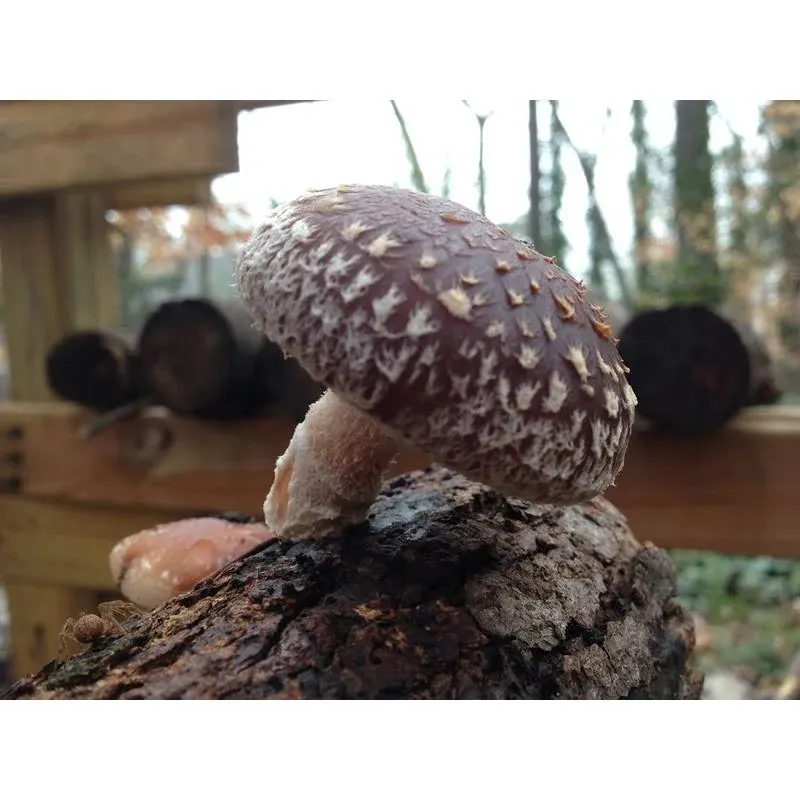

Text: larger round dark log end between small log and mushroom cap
xmin=138 ymin=298 xmax=266 ymax=420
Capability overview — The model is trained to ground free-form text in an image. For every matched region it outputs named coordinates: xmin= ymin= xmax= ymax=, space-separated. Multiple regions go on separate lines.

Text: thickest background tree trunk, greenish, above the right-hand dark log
xmin=673 ymin=100 xmax=724 ymax=305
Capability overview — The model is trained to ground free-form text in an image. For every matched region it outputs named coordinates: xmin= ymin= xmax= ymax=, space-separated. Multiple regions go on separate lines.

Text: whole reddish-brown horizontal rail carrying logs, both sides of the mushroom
xmin=0 ymin=403 xmax=800 ymax=557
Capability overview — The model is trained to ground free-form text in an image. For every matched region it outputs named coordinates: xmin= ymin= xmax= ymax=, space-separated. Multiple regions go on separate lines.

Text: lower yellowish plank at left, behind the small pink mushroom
xmin=0 ymin=494 xmax=190 ymax=591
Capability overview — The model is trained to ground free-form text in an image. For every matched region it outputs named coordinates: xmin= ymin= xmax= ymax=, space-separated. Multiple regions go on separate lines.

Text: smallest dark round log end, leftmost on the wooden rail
xmin=45 ymin=330 xmax=139 ymax=412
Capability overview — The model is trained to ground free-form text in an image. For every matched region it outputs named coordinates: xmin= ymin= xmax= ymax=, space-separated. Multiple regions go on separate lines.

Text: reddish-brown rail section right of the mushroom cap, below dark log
xmin=606 ymin=406 xmax=800 ymax=558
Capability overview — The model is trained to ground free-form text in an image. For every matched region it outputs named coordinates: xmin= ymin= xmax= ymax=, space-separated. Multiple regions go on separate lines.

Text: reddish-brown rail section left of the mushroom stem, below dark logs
xmin=0 ymin=403 xmax=430 ymax=515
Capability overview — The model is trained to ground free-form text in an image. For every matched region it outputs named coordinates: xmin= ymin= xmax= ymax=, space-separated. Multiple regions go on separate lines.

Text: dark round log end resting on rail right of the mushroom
xmin=619 ymin=304 xmax=780 ymax=435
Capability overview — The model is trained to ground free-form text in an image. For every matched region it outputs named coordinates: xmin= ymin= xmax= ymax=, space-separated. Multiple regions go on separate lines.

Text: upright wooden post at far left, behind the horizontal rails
xmin=0 ymin=190 xmax=120 ymax=676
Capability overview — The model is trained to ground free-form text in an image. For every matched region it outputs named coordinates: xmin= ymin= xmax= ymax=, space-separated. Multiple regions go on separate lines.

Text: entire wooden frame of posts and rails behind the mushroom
xmin=0 ymin=101 xmax=800 ymax=676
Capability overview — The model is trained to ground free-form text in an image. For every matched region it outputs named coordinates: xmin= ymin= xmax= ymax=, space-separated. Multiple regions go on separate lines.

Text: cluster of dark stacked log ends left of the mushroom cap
xmin=46 ymin=298 xmax=323 ymax=422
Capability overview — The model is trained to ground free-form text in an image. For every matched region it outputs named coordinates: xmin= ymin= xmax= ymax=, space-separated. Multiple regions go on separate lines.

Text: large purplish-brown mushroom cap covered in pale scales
xmin=236 ymin=185 xmax=636 ymax=504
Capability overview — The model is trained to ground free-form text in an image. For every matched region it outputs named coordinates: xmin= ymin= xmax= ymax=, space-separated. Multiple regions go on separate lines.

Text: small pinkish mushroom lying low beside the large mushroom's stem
xmin=109 ymin=517 xmax=273 ymax=609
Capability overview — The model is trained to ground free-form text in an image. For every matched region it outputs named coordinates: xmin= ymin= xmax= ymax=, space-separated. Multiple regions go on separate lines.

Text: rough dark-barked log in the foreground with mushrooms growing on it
xmin=2 ymin=468 xmax=702 ymax=699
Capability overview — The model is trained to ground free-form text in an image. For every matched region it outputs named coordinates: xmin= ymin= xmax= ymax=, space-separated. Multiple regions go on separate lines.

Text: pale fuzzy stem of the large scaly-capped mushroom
xmin=264 ymin=391 xmax=399 ymax=539
